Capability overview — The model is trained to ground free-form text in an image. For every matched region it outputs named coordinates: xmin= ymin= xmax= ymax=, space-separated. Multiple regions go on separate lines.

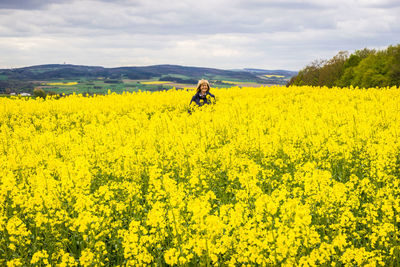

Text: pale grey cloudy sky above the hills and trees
xmin=0 ymin=0 xmax=400 ymax=71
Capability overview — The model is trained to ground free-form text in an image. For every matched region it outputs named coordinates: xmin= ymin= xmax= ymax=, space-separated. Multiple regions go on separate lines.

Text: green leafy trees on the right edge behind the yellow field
xmin=287 ymin=44 xmax=400 ymax=88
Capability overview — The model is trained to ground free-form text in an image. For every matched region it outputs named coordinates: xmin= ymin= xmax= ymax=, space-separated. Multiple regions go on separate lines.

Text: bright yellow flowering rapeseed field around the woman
xmin=0 ymin=87 xmax=400 ymax=266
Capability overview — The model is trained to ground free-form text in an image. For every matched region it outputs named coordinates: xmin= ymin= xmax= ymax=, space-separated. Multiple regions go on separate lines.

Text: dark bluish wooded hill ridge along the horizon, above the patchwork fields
xmin=0 ymin=64 xmax=296 ymax=82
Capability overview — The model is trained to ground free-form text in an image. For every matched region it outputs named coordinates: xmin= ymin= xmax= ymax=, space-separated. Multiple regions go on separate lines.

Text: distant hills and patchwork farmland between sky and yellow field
xmin=0 ymin=65 xmax=295 ymax=95
